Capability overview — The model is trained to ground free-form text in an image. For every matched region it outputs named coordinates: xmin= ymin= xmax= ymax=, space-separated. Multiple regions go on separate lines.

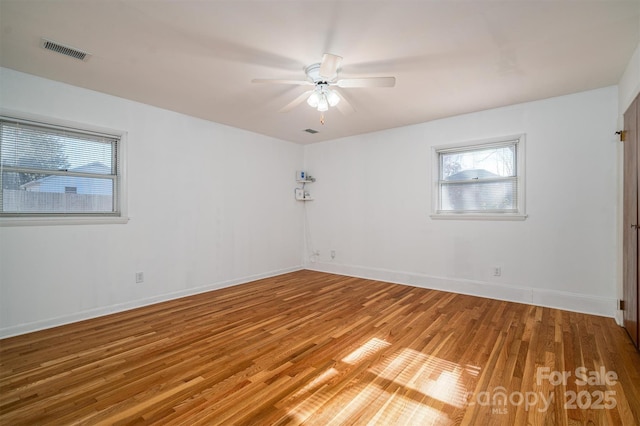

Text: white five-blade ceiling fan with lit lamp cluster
xmin=252 ymin=53 xmax=396 ymax=114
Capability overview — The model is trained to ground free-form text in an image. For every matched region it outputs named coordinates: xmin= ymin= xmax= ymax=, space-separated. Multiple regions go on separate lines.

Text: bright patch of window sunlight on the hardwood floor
xmin=289 ymin=338 xmax=480 ymax=425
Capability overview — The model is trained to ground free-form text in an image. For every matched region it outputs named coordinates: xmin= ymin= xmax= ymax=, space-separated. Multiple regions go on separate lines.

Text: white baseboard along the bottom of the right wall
xmin=305 ymin=262 xmax=618 ymax=319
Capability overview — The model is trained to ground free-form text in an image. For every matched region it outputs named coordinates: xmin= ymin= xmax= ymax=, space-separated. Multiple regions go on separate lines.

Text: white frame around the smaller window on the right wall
xmin=430 ymin=133 xmax=527 ymax=220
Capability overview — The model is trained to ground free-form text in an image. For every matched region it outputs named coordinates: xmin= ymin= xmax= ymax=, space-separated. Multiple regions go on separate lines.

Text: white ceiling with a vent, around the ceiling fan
xmin=0 ymin=0 xmax=640 ymax=143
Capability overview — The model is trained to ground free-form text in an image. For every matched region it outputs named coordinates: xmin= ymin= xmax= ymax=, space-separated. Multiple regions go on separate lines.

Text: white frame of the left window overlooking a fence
xmin=0 ymin=108 xmax=129 ymax=226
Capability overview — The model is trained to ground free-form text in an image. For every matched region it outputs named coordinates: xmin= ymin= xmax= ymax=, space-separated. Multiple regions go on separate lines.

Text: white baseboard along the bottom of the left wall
xmin=0 ymin=265 xmax=303 ymax=339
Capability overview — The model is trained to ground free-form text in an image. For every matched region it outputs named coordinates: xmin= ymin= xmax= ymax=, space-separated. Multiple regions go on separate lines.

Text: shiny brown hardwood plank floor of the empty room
xmin=0 ymin=271 xmax=640 ymax=425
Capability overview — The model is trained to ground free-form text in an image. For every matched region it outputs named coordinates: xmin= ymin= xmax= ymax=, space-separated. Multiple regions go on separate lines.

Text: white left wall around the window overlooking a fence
xmin=0 ymin=68 xmax=303 ymax=337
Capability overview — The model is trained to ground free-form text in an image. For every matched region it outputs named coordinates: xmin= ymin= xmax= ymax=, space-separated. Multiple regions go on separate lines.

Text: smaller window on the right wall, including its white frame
xmin=432 ymin=135 xmax=526 ymax=219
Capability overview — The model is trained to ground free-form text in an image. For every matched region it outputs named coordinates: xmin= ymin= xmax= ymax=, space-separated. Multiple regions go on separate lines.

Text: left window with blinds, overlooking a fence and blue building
xmin=0 ymin=116 xmax=123 ymax=225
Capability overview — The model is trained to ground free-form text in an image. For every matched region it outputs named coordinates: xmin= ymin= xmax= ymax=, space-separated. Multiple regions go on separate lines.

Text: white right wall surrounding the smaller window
xmin=305 ymin=87 xmax=618 ymax=316
